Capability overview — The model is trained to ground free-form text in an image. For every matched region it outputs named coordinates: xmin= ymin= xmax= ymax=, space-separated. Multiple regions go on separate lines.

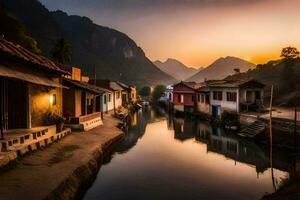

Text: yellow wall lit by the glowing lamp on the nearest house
xmin=28 ymin=78 xmax=63 ymax=127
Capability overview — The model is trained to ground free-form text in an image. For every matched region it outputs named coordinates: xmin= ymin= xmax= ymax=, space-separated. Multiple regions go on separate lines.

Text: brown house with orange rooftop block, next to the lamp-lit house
xmin=63 ymin=67 xmax=106 ymax=131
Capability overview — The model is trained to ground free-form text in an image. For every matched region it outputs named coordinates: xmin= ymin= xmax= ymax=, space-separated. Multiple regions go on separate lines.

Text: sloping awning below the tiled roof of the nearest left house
xmin=0 ymin=64 xmax=63 ymax=88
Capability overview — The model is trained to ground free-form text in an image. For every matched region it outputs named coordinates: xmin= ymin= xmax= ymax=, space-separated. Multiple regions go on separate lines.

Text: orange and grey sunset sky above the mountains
xmin=40 ymin=0 xmax=300 ymax=68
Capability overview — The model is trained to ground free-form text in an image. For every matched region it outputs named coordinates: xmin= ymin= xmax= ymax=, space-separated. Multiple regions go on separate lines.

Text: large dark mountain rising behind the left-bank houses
xmin=4 ymin=0 xmax=176 ymax=86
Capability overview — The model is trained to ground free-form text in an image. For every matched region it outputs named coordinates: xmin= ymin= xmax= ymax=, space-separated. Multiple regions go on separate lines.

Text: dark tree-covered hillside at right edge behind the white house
xmin=226 ymin=58 xmax=300 ymax=105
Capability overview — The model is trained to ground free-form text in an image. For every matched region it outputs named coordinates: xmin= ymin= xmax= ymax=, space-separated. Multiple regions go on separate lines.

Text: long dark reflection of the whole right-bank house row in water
xmin=173 ymin=118 xmax=291 ymax=173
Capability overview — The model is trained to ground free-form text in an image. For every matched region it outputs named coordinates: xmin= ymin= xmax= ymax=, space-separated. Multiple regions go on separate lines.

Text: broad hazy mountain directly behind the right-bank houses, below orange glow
xmin=187 ymin=56 xmax=255 ymax=82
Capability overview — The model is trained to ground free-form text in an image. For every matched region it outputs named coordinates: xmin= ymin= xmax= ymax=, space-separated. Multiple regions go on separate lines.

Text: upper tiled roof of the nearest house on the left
xmin=0 ymin=38 xmax=68 ymax=74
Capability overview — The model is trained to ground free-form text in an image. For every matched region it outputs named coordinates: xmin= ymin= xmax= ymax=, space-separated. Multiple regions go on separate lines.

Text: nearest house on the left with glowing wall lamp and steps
xmin=0 ymin=38 xmax=70 ymax=157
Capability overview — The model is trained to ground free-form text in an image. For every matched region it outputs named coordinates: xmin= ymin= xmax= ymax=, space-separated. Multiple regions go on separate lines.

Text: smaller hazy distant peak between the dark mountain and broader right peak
xmin=153 ymin=58 xmax=198 ymax=80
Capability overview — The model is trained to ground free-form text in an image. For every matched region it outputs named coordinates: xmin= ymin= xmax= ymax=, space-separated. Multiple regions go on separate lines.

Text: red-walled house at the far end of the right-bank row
xmin=173 ymin=81 xmax=203 ymax=113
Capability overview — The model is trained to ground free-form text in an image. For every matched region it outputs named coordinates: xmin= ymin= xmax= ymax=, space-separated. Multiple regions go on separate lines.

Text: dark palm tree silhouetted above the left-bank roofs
xmin=51 ymin=38 xmax=72 ymax=64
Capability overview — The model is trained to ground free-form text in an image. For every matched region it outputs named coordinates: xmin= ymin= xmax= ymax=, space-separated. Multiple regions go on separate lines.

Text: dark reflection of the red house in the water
xmin=173 ymin=118 xmax=197 ymax=141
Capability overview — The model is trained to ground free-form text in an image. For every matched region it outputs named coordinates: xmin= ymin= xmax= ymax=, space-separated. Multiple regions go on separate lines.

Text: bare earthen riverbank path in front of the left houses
xmin=0 ymin=114 xmax=124 ymax=200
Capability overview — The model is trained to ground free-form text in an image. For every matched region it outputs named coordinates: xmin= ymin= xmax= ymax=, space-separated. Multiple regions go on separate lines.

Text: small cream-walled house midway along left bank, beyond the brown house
xmin=96 ymin=79 xmax=124 ymax=111
